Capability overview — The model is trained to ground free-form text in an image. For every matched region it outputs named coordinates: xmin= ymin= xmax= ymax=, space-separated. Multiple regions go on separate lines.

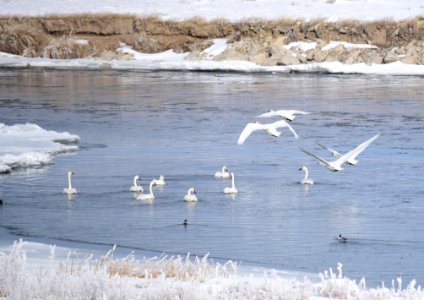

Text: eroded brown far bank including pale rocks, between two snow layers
xmin=0 ymin=14 xmax=424 ymax=65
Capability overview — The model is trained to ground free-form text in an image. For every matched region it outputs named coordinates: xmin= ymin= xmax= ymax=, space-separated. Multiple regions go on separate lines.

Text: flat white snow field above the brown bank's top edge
xmin=0 ymin=0 xmax=424 ymax=21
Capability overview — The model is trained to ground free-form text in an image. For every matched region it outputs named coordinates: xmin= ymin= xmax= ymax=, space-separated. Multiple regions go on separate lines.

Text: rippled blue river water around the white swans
xmin=0 ymin=70 xmax=424 ymax=286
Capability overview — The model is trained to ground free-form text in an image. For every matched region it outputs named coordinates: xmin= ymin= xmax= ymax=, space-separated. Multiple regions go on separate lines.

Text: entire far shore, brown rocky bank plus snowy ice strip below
xmin=0 ymin=14 xmax=424 ymax=75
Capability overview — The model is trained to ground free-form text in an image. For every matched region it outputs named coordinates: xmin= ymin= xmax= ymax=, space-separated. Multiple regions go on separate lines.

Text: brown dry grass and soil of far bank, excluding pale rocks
xmin=0 ymin=14 xmax=424 ymax=58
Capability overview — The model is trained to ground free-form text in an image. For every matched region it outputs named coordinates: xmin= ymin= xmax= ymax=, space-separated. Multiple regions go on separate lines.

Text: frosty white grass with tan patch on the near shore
xmin=0 ymin=241 xmax=424 ymax=300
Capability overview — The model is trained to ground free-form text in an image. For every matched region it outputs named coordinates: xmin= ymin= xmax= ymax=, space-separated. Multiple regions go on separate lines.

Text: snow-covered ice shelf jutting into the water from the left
xmin=0 ymin=123 xmax=79 ymax=173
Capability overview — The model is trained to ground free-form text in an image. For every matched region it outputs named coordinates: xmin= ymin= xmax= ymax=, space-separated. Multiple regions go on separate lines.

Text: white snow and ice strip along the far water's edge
xmin=0 ymin=50 xmax=424 ymax=76
